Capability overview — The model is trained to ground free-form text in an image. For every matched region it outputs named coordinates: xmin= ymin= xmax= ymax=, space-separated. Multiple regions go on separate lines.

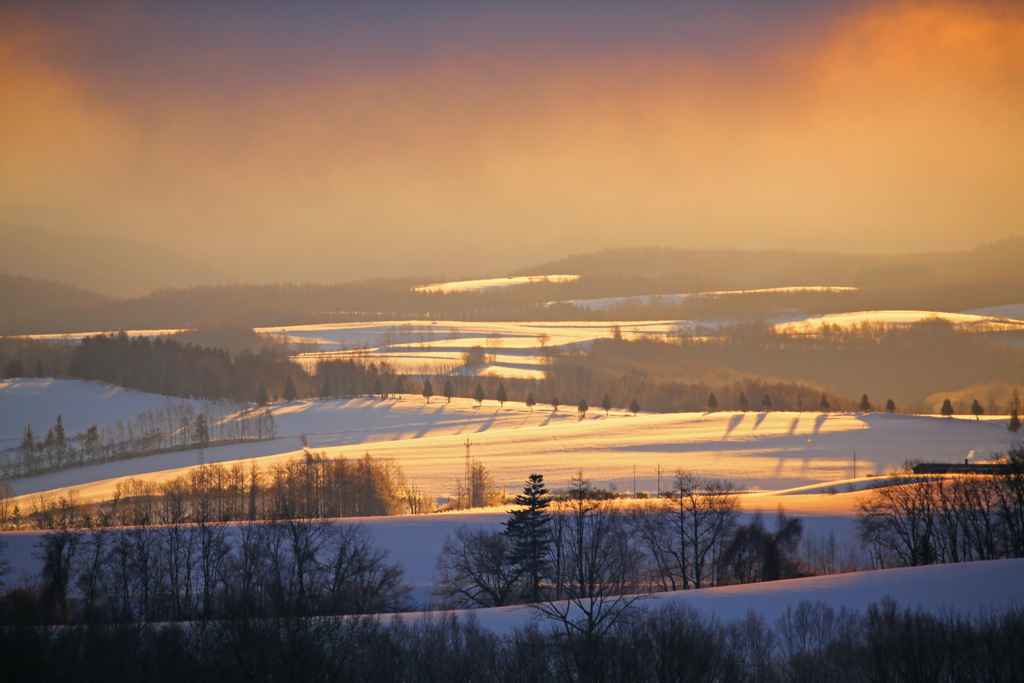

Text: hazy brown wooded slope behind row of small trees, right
xmin=571 ymin=321 xmax=1024 ymax=413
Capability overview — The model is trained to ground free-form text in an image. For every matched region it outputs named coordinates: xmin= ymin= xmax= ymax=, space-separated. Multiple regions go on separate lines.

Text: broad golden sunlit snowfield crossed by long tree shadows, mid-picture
xmin=0 ymin=379 xmax=1014 ymax=512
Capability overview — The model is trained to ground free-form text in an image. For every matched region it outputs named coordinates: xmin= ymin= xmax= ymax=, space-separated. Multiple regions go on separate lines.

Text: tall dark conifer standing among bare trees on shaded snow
xmin=505 ymin=474 xmax=551 ymax=602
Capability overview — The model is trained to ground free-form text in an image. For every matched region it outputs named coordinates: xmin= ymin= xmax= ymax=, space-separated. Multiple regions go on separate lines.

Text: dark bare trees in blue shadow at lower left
xmin=0 ymin=519 xmax=410 ymax=625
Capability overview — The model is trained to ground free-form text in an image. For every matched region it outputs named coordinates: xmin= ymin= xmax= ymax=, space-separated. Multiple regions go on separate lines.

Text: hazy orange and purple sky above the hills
xmin=0 ymin=0 xmax=1024 ymax=281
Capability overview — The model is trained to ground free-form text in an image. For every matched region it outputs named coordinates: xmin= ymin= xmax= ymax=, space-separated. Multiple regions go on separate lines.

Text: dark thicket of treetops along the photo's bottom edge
xmin=0 ymin=598 xmax=1024 ymax=683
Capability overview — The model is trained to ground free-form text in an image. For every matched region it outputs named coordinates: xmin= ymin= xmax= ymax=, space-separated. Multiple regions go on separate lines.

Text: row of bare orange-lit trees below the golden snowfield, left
xmin=18 ymin=451 xmax=413 ymax=529
